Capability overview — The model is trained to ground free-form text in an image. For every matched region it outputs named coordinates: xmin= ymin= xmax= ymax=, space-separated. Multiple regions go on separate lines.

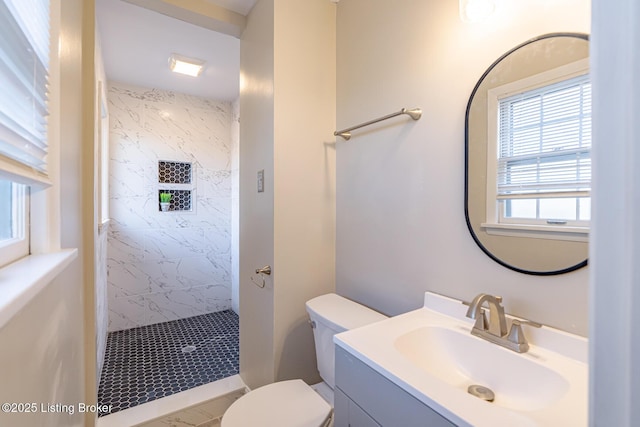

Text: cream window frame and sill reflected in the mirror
xmin=481 ymin=58 xmax=590 ymax=242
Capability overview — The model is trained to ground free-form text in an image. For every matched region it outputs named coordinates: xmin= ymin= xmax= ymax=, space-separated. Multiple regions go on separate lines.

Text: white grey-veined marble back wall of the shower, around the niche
xmin=108 ymin=83 xmax=233 ymax=331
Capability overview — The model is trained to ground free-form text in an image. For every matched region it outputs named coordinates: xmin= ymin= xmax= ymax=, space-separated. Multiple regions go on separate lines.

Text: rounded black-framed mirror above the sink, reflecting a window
xmin=465 ymin=33 xmax=591 ymax=275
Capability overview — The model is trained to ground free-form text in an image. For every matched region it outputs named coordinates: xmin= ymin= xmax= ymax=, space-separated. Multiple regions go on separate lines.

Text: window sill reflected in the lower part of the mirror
xmin=480 ymin=223 xmax=589 ymax=242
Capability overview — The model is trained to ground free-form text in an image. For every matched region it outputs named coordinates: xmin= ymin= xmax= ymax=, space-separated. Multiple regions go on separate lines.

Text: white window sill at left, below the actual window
xmin=0 ymin=249 xmax=78 ymax=329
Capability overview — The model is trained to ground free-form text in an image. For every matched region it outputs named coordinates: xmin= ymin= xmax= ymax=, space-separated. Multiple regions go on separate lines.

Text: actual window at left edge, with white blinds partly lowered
xmin=0 ymin=0 xmax=49 ymax=266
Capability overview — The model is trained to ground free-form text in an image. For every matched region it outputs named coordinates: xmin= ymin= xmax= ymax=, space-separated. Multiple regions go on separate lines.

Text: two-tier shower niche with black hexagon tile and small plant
xmin=158 ymin=160 xmax=194 ymax=212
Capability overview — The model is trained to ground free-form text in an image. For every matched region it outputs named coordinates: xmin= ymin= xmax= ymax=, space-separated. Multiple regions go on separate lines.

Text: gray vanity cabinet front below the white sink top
xmin=334 ymin=346 xmax=455 ymax=427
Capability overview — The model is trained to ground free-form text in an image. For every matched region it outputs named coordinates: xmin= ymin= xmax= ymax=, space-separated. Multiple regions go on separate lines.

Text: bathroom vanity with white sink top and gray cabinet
xmin=334 ymin=293 xmax=588 ymax=427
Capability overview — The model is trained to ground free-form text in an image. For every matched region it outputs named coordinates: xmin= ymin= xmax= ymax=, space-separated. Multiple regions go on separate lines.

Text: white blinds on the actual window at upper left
xmin=0 ymin=0 xmax=49 ymax=172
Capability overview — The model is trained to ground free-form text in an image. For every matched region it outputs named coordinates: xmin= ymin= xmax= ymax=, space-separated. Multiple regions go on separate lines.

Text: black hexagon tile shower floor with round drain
xmin=98 ymin=310 xmax=240 ymax=415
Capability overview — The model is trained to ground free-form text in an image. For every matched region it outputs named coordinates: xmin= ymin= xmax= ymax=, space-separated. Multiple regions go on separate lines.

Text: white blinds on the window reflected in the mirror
xmin=498 ymin=74 xmax=591 ymax=199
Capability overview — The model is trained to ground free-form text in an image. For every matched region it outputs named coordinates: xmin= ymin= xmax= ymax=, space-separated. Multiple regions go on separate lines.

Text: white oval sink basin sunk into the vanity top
xmin=394 ymin=326 xmax=569 ymax=411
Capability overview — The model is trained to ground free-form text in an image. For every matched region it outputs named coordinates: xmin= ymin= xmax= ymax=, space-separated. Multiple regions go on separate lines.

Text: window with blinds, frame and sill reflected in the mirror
xmin=483 ymin=61 xmax=591 ymax=240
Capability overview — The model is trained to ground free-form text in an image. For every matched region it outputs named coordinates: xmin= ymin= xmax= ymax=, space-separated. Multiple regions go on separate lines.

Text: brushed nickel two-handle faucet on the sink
xmin=467 ymin=294 xmax=542 ymax=353
